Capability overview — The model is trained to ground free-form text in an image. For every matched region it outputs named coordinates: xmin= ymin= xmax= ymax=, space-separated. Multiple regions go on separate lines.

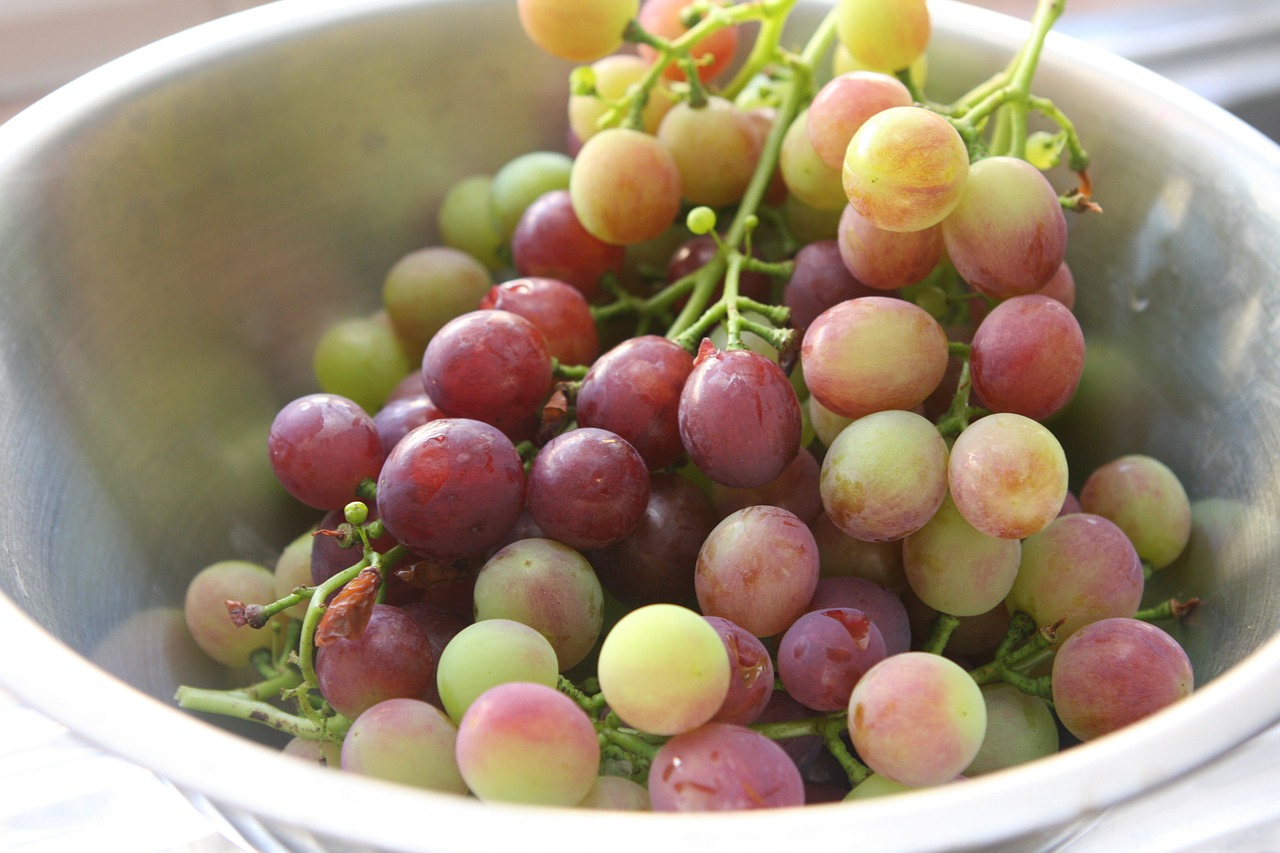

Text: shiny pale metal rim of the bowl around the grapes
xmin=0 ymin=0 xmax=1280 ymax=852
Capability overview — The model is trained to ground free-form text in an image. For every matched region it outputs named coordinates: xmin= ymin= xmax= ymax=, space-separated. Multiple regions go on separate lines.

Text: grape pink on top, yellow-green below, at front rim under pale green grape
xmin=457 ymin=681 xmax=600 ymax=806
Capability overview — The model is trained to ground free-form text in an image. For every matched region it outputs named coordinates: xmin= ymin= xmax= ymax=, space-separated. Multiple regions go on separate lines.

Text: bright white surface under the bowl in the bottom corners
xmin=0 ymin=690 xmax=1280 ymax=853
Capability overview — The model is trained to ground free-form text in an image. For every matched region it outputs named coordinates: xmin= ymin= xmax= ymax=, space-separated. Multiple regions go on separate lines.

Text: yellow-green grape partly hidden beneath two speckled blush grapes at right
xmin=902 ymin=496 xmax=1023 ymax=616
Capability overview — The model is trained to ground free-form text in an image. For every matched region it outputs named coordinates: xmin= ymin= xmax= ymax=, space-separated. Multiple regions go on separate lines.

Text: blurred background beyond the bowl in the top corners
xmin=0 ymin=0 xmax=1280 ymax=140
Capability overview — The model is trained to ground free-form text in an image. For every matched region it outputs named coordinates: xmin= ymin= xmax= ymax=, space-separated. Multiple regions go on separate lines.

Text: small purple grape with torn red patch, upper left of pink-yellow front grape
xmin=778 ymin=607 xmax=886 ymax=711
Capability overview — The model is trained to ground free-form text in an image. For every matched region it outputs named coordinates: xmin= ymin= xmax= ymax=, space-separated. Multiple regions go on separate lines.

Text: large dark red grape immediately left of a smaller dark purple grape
xmin=378 ymin=418 xmax=525 ymax=561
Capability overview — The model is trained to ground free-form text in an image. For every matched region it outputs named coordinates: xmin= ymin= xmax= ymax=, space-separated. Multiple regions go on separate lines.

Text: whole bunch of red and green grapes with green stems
xmin=179 ymin=0 xmax=1193 ymax=811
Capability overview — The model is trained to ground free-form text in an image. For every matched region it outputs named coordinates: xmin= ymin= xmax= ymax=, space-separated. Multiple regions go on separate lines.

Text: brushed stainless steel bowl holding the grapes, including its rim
xmin=0 ymin=0 xmax=1280 ymax=853
